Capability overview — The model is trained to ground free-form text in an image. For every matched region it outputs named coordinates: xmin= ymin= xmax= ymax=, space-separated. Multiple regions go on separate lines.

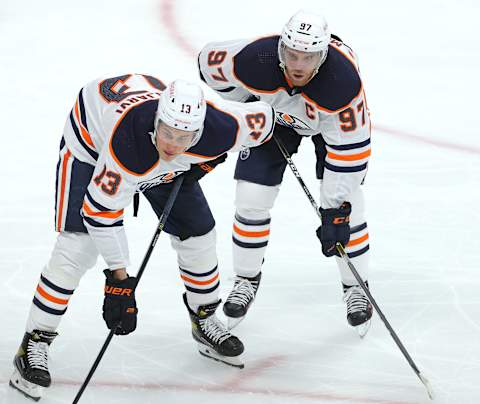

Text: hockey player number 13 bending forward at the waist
xmin=10 ymin=74 xmax=274 ymax=400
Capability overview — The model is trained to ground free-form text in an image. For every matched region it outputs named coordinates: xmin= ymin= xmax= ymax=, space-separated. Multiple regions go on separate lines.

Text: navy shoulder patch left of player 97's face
xmin=233 ymin=35 xmax=286 ymax=92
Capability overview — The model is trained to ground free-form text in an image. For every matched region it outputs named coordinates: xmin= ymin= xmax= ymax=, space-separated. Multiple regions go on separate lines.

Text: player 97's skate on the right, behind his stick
xmin=343 ymin=282 xmax=373 ymax=338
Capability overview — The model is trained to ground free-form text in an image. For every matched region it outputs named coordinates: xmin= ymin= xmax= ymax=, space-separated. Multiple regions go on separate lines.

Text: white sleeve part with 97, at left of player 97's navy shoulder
xmin=198 ymin=40 xmax=252 ymax=102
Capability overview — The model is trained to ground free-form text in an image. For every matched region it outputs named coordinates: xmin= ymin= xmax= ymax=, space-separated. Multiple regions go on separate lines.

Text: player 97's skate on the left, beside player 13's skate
xmin=223 ymin=272 xmax=262 ymax=330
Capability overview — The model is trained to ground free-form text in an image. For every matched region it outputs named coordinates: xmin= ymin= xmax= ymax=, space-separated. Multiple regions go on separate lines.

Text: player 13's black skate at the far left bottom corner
xmin=10 ymin=330 xmax=57 ymax=401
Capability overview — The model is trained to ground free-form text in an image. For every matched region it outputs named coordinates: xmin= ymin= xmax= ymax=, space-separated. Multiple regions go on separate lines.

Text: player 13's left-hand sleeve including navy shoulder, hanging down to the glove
xmin=81 ymin=103 xmax=158 ymax=270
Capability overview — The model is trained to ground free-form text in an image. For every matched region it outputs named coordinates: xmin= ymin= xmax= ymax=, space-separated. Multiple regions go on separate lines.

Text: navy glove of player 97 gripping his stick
xmin=317 ymin=202 xmax=352 ymax=257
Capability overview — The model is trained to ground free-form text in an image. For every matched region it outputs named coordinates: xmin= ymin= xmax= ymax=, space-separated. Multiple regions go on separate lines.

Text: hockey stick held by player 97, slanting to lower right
xmin=273 ymin=135 xmax=434 ymax=400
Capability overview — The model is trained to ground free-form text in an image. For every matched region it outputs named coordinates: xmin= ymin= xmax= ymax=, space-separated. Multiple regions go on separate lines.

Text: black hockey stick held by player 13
xmin=72 ymin=175 xmax=184 ymax=404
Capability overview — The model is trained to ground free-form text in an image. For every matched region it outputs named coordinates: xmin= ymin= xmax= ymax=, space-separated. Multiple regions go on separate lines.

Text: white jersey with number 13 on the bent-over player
xmin=64 ymin=74 xmax=275 ymax=269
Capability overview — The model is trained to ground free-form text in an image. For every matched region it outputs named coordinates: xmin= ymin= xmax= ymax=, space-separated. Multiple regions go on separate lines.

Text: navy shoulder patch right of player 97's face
xmin=302 ymin=45 xmax=362 ymax=112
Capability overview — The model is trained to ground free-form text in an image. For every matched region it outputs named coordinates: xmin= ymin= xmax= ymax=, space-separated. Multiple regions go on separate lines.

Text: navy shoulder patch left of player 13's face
xmin=110 ymin=100 xmax=159 ymax=175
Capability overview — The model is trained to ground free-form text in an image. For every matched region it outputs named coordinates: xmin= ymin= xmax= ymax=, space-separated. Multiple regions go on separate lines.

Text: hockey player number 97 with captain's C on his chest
xmin=198 ymin=11 xmax=372 ymax=336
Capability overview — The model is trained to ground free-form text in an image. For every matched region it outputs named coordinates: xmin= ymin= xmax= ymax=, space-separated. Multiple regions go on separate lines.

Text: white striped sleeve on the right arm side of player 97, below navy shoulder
xmin=320 ymin=91 xmax=370 ymax=209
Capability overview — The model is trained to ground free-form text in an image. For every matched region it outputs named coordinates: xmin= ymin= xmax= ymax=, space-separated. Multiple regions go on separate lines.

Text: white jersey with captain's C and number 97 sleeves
xmin=198 ymin=36 xmax=370 ymax=208
